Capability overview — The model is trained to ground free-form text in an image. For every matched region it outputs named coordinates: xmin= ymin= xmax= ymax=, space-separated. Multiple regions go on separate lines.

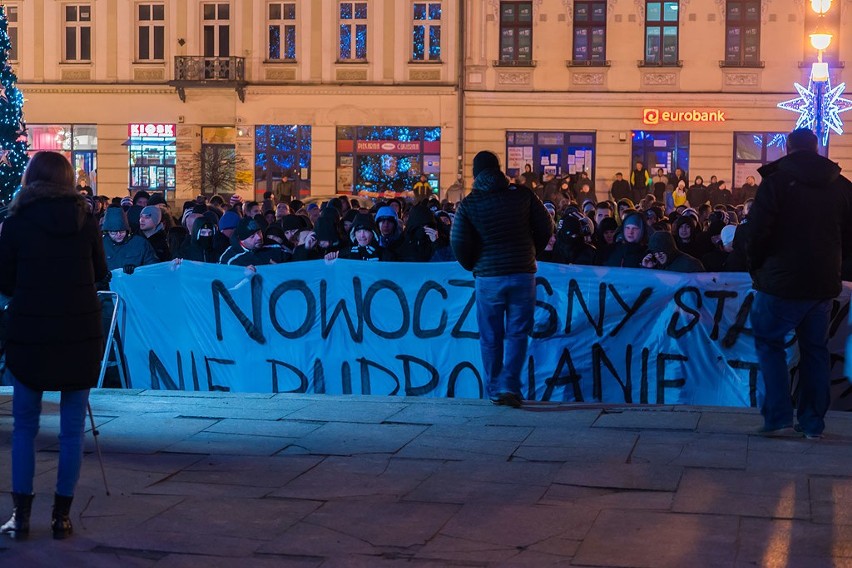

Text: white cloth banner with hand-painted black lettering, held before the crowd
xmin=112 ymin=260 xmax=852 ymax=408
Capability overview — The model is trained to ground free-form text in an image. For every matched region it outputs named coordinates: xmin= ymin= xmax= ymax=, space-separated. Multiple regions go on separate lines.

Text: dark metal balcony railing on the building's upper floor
xmin=169 ymin=55 xmax=248 ymax=102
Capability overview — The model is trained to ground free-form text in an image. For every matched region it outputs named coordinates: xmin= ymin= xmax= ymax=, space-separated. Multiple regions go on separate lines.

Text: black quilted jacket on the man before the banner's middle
xmin=450 ymin=170 xmax=553 ymax=276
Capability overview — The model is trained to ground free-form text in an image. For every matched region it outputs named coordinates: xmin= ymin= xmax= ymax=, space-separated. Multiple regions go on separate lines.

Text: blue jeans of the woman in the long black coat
xmin=6 ymin=369 xmax=89 ymax=497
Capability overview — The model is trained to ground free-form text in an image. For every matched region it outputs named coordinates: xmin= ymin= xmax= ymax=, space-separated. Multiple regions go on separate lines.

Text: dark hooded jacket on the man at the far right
xmin=735 ymin=151 xmax=852 ymax=300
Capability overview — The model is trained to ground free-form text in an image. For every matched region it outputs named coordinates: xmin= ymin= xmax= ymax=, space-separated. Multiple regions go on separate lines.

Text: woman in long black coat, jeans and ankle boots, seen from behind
xmin=0 ymin=152 xmax=107 ymax=538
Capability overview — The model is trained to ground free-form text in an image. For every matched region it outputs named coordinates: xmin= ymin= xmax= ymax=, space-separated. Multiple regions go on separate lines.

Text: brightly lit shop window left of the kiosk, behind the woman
xmin=27 ymin=124 xmax=98 ymax=193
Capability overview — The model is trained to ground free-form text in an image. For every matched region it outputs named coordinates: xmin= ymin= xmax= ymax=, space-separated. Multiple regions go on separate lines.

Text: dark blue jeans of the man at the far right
xmin=751 ymin=292 xmax=831 ymax=434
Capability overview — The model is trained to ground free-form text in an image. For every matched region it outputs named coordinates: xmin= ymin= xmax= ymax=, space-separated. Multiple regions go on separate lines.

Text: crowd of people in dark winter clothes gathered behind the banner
xmin=31 ymin=163 xmax=772 ymax=280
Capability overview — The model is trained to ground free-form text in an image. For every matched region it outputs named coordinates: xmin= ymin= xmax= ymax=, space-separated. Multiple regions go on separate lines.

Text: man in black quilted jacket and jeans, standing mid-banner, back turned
xmin=450 ymin=151 xmax=553 ymax=408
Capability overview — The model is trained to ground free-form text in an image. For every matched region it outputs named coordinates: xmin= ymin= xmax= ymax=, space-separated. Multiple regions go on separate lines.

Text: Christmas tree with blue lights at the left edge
xmin=0 ymin=5 xmax=29 ymax=205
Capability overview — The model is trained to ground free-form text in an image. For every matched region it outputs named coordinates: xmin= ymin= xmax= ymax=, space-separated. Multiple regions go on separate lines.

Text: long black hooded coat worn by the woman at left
xmin=0 ymin=183 xmax=107 ymax=390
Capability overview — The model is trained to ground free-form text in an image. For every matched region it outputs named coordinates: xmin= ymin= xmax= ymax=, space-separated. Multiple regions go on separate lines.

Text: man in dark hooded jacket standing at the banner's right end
xmin=746 ymin=128 xmax=852 ymax=438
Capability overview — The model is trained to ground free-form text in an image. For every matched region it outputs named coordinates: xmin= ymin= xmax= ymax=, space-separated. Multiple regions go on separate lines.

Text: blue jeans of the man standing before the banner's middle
xmin=476 ymin=273 xmax=535 ymax=398
